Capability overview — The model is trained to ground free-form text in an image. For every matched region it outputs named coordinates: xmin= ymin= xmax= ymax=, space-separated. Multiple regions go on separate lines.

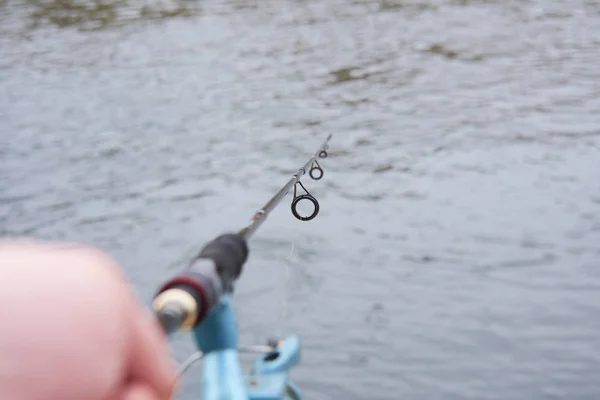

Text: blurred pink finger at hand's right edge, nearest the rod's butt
xmin=129 ymin=301 xmax=176 ymax=399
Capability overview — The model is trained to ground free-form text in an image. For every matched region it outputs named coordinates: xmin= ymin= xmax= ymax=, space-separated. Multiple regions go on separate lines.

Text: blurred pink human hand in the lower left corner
xmin=0 ymin=241 xmax=175 ymax=400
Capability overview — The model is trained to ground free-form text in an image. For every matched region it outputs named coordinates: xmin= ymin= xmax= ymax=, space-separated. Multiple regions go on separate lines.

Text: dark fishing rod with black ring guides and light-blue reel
xmin=152 ymin=135 xmax=332 ymax=400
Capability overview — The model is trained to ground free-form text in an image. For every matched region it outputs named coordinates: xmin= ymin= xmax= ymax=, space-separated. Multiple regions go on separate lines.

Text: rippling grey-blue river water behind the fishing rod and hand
xmin=0 ymin=0 xmax=600 ymax=400
